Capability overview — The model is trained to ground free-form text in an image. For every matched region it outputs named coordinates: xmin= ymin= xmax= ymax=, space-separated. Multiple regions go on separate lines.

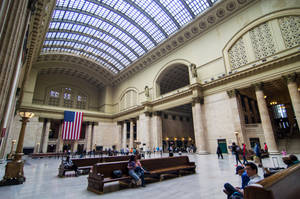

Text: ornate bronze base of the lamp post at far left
xmin=0 ymin=160 xmax=26 ymax=186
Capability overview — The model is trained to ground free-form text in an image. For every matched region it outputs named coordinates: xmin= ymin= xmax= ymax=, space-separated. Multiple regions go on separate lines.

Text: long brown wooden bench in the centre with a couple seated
xmin=87 ymin=156 xmax=196 ymax=194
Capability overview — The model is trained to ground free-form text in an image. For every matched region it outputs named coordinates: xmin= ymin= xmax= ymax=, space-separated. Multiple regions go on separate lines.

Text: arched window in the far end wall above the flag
xmin=45 ymin=87 xmax=88 ymax=109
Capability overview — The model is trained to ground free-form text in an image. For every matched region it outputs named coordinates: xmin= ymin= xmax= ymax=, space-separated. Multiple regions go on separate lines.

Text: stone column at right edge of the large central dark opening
xmin=192 ymin=97 xmax=208 ymax=154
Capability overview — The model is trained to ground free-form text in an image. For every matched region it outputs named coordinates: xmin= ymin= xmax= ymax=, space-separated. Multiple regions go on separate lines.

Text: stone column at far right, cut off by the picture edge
xmin=287 ymin=75 xmax=300 ymax=127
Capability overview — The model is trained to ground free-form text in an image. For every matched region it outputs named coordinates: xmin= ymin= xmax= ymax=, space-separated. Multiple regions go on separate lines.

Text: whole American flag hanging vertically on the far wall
xmin=62 ymin=111 xmax=83 ymax=140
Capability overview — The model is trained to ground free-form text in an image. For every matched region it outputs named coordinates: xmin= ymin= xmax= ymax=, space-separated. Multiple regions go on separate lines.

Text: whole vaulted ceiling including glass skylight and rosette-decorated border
xmin=36 ymin=0 xmax=254 ymax=85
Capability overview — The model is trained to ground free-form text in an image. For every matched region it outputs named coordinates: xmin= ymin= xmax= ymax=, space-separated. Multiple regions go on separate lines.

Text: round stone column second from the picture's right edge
xmin=255 ymin=84 xmax=279 ymax=154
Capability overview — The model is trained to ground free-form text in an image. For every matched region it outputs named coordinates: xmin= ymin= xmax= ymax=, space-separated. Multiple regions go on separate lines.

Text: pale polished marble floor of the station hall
xmin=0 ymin=154 xmax=300 ymax=199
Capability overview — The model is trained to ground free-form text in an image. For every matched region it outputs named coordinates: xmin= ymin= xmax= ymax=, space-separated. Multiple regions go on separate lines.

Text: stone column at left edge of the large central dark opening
xmin=152 ymin=111 xmax=162 ymax=148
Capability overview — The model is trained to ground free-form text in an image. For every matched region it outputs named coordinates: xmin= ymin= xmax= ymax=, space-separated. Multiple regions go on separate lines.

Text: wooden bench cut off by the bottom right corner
xmin=244 ymin=164 xmax=300 ymax=199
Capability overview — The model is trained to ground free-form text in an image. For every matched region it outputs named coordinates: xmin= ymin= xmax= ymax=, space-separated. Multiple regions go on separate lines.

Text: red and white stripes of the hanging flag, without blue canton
xmin=62 ymin=112 xmax=83 ymax=140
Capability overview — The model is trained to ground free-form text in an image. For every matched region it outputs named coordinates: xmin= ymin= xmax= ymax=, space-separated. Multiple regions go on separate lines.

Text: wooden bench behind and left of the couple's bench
xmin=58 ymin=156 xmax=130 ymax=177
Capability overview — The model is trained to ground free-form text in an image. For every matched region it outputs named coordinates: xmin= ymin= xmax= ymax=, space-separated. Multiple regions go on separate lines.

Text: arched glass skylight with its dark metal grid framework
xmin=42 ymin=0 xmax=217 ymax=74
